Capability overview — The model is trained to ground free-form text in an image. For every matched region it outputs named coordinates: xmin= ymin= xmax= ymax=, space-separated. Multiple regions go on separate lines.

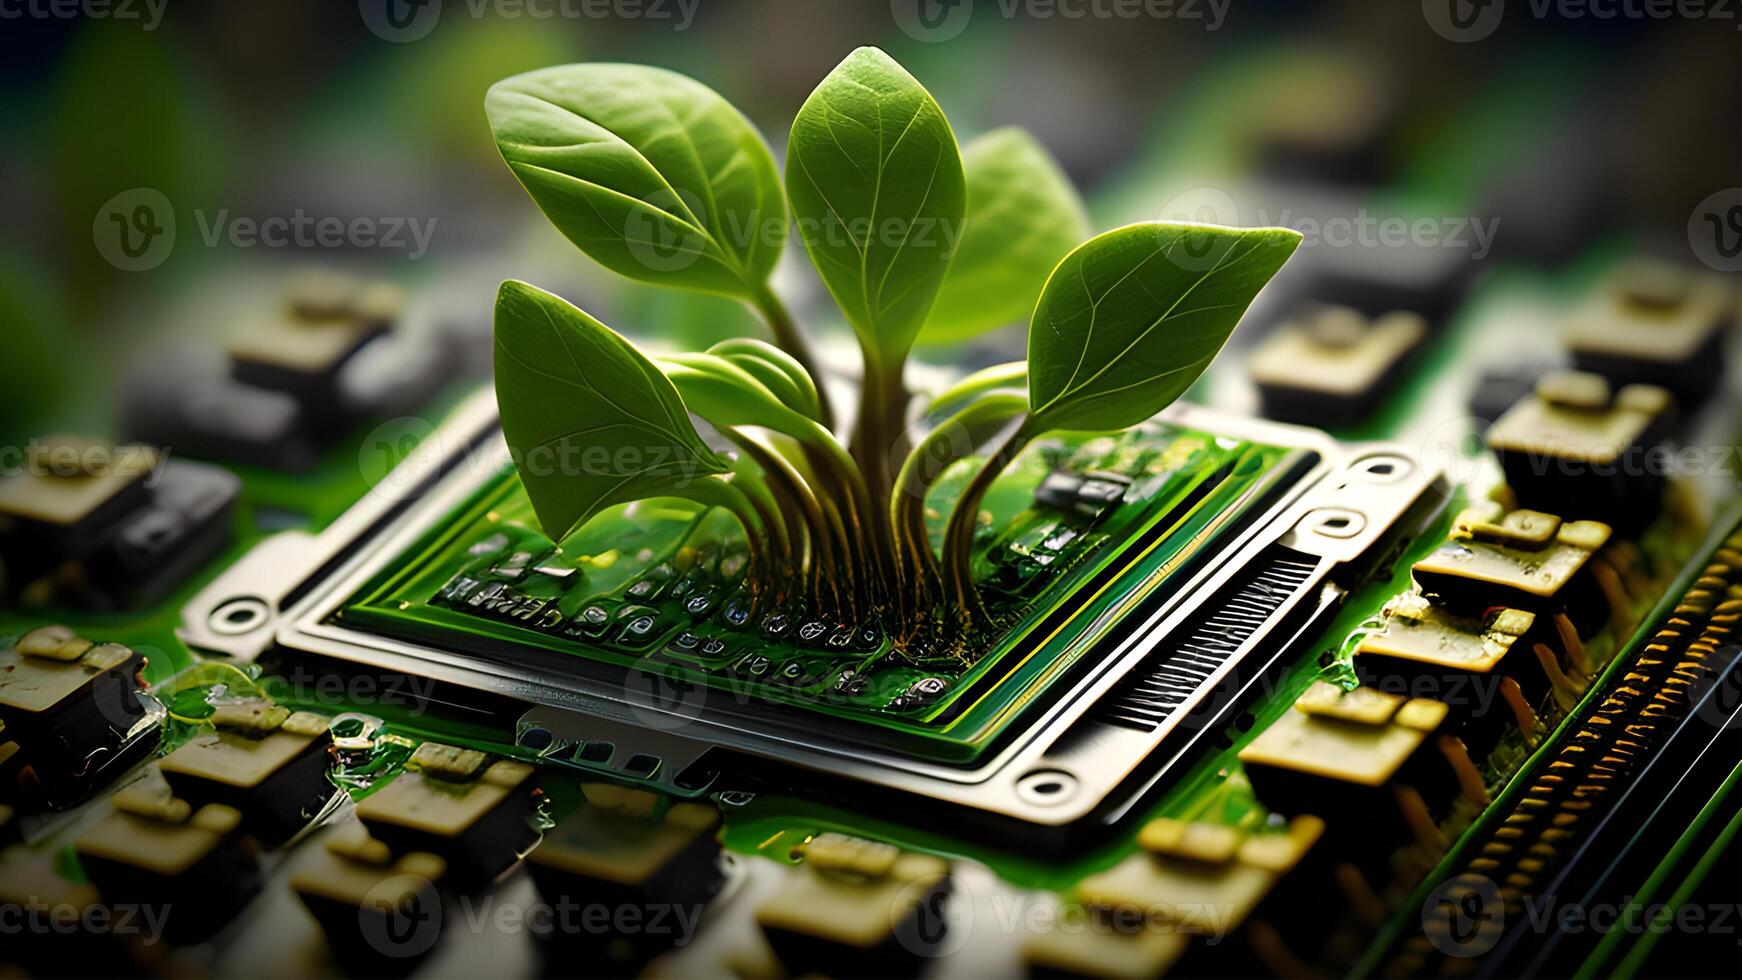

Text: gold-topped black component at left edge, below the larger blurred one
xmin=0 ymin=627 xmax=159 ymax=808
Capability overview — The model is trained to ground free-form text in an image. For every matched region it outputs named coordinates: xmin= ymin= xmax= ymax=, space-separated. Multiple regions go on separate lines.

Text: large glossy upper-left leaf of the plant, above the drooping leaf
xmin=484 ymin=64 xmax=786 ymax=298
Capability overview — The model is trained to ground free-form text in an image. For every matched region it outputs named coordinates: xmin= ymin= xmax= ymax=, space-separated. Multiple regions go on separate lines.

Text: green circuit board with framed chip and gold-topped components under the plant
xmin=0 ymin=13 xmax=1742 ymax=978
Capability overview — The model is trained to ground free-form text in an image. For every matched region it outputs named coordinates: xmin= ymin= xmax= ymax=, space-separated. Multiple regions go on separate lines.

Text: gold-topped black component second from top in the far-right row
xmin=1488 ymin=371 xmax=1674 ymax=534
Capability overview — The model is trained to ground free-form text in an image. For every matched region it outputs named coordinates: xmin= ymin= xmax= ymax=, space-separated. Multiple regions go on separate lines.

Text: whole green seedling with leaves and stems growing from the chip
xmin=486 ymin=47 xmax=1300 ymax=637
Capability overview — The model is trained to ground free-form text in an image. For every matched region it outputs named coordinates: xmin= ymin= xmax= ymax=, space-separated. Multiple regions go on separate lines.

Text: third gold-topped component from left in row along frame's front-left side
xmin=357 ymin=742 xmax=542 ymax=889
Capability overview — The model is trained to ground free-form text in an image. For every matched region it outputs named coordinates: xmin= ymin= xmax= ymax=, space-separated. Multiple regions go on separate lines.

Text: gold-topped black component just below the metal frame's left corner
xmin=159 ymin=701 xmax=338 ymax=848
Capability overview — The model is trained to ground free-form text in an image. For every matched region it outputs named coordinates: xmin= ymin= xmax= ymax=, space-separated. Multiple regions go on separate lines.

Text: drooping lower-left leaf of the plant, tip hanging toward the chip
xmin=496 ymin=280 xmax=730 ymax=541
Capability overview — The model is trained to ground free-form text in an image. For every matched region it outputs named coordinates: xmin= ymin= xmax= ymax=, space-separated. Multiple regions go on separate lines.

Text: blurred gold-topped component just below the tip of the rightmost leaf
xmin=1247 ymin=306 xmax=1427 ymax=428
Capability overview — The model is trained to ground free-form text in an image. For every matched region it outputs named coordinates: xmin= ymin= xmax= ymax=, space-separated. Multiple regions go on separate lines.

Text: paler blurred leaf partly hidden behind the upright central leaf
xmin=920 ymin=127 xmax=1089 ymax=345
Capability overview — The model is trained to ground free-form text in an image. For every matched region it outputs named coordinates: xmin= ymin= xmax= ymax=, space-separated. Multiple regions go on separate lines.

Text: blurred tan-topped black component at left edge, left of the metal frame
xmin=0 ymin=437 xmax=242 ymax=611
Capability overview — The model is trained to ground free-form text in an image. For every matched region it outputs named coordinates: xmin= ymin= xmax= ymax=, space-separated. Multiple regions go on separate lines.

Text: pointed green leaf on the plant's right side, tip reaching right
xmin=1028 ymin=225 xmax=1301 ymax=432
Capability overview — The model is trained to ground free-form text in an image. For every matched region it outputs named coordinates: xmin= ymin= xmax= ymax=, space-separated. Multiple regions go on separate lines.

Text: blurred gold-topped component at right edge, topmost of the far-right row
xmin=1563 ymin=263 xmax=1737 ymax=409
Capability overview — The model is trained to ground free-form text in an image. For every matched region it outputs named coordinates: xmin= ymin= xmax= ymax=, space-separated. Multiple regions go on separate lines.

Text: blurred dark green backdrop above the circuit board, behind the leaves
xmin=0 ymin=0 xmax=1742 ymax=472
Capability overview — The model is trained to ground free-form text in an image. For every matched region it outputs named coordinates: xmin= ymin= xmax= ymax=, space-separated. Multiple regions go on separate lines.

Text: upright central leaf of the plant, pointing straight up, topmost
xmin=786 ymin=47 xmax=967 ymax=374
